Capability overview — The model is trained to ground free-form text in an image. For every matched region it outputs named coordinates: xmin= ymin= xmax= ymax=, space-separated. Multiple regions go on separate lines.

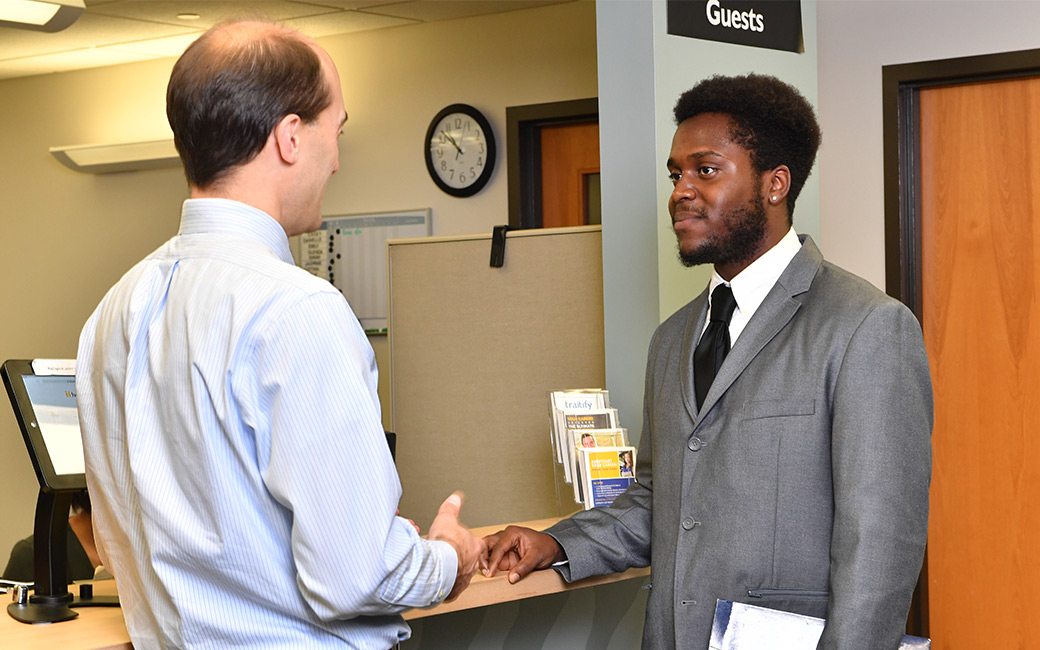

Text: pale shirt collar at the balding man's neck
xmin=177 ymin=199 xmax=295 ymax=264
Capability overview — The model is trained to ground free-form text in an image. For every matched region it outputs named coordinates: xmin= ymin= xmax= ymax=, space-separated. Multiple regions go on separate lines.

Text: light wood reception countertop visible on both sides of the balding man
xmin=0 ymin=518 xmax=650 ymax=650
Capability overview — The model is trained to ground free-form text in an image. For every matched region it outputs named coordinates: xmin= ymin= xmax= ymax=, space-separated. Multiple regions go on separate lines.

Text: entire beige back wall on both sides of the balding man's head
xmin=0 ymin=1 xmax=597 ymax=562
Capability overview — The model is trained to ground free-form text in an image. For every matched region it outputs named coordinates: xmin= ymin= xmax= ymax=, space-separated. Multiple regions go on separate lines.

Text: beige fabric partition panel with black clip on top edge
xmin=388 ymin=226 xmax=603 ymax=531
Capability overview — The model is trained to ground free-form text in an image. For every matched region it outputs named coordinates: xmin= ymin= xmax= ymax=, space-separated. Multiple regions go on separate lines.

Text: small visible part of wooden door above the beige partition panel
xmin=541 ymin=122 xmax=599 ymax=228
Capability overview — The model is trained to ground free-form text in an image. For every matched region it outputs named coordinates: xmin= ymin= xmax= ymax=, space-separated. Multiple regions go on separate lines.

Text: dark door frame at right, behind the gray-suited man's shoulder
xmin=881 ymin=49 xmax=1040 ymax=636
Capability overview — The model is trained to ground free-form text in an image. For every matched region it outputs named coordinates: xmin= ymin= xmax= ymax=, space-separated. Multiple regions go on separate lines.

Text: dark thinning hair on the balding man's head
xmin=166 ymin=19 xmax=332 ymax=188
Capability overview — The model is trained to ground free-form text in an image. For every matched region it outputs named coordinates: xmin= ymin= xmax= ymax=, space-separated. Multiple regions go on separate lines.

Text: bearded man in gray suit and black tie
xmin=487 ymin=75 xmax=932 ymax=650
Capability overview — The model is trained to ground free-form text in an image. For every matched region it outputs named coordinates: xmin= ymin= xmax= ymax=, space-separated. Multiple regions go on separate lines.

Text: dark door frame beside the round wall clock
xmin=505 ymin=97 xmax=599 ymax=230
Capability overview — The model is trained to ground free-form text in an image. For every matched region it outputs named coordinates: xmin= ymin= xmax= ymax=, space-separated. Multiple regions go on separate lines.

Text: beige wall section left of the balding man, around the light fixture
xmin=0 ymin=62 xmax=186 ymax=564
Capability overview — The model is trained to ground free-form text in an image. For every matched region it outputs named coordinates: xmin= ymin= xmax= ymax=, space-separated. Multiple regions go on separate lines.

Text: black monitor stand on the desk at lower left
xmin=7 ymin=490 xmax=120 ymax=623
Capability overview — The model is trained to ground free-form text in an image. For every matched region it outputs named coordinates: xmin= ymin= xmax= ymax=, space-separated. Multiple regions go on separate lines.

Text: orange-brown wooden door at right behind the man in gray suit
xmin=919 ymin=78 xmax=1040 ymax=650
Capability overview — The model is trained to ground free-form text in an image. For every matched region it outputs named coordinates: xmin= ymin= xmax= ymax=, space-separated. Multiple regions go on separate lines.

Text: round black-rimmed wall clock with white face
xmin=425 ymin=104 xmax=495 ymax=197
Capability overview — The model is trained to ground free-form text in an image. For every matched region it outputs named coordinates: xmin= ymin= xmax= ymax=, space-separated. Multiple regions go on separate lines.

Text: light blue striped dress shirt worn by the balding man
xmin=76 ymin=199 xmax=458 ymax=650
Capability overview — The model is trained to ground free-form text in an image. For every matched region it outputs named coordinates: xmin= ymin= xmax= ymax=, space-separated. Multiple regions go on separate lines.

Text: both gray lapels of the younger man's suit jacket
xmin=683 ymin=235 xmax=824 ymax=424
